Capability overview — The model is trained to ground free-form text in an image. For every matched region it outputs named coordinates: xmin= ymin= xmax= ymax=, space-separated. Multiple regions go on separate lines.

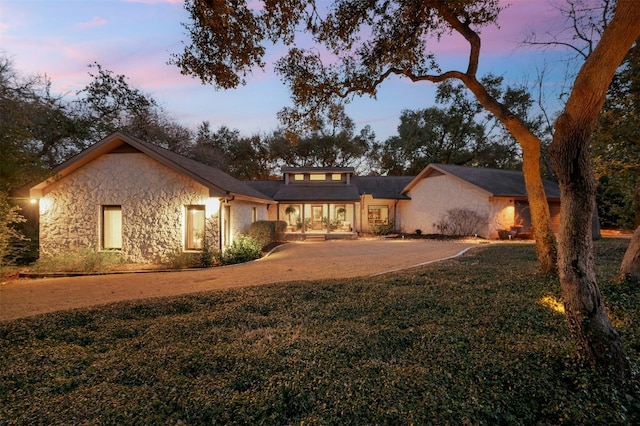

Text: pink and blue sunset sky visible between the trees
xmin=0 ymin=0 xmax=576 ymax=141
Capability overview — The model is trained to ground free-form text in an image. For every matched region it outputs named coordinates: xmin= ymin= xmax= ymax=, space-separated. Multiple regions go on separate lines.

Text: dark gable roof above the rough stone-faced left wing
xmin=30 ymin=132 xmax=272 ymax=203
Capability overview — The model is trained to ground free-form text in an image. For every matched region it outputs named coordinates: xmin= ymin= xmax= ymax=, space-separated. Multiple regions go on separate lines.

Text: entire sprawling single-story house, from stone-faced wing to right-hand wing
xmin=30 ymin=132 xmax=560 ymax=263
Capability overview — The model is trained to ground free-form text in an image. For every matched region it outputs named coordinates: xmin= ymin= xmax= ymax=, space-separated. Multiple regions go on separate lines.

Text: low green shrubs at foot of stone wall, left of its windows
xmin=32 ymin=249 xmax=125 ymax=272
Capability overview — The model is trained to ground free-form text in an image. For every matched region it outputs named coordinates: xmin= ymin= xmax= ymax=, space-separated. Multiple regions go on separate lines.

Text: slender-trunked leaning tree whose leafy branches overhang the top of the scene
xmin=172 ymin=0 xmax=556 ymax=272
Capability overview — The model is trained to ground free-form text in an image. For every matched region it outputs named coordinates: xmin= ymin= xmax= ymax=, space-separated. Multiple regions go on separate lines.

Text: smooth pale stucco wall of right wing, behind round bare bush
xmin=401 ymin=175 xmax=513 ymax=238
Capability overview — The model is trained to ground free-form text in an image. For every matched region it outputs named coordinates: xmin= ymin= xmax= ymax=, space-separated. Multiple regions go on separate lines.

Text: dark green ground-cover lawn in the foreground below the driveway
xmin=0 ymin=240 xmax=640 ymax=425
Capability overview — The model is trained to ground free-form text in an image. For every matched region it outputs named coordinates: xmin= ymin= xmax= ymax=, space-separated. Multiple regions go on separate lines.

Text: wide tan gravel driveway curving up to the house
xmin=0 ymin=240 xmax=475 ymax=321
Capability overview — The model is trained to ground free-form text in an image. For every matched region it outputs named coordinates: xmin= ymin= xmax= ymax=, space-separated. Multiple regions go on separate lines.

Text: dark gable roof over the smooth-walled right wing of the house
xmin=402 ymin=164 xmax=560 ymax=200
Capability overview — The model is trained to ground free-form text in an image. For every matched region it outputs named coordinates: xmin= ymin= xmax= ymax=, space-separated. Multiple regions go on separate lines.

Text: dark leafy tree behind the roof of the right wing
xmin=380 ymin=75 xmax=543 ymax=174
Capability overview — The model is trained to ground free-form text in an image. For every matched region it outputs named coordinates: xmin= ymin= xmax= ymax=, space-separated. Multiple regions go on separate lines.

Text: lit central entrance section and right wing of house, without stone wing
xmin=247 ymin=164 xmax=560 ymax=239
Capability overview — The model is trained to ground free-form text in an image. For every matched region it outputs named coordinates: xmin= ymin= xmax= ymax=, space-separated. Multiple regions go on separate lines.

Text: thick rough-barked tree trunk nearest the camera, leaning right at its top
xmin=549 ymin=0 xmax=640 ymax=382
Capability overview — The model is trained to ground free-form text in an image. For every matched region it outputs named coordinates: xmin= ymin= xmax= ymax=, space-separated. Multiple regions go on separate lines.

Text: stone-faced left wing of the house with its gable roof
xmin=30 ymin=132 xmax=273 ymax=263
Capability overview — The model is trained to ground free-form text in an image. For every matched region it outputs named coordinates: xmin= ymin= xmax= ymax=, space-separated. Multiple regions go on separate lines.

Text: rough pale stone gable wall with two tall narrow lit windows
xmin=40 ymin=153 xmax=217 ymax=262
